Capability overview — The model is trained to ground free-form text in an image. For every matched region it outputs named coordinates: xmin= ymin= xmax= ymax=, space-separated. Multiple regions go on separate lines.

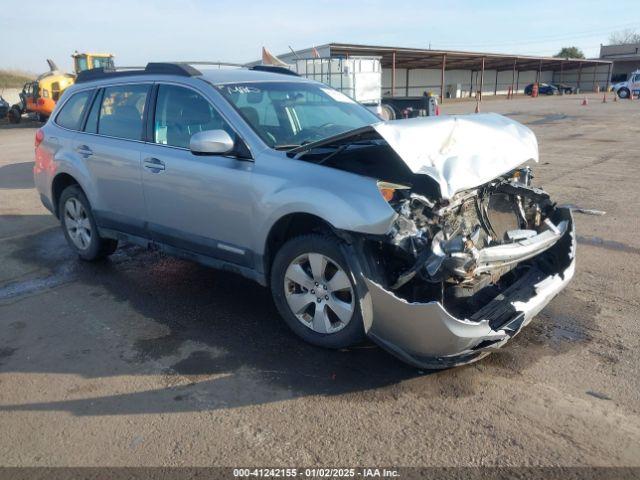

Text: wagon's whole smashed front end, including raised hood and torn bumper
xmin=288 ymin=114 xmax=575 ymax=368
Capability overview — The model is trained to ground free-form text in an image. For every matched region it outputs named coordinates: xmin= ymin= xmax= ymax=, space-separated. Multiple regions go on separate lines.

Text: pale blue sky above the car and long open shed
xmin=0 ymin=0 xmax=640 ymax=72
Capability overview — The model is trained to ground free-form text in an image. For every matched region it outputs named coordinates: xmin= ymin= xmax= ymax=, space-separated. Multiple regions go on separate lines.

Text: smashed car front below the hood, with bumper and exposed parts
xmin=348 ymin=168 xmax=575 ymax=368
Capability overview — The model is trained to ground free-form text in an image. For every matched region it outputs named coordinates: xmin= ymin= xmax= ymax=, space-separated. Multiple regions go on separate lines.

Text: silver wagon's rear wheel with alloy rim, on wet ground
xmin=58 ymin=185 xmax=118 ymax=262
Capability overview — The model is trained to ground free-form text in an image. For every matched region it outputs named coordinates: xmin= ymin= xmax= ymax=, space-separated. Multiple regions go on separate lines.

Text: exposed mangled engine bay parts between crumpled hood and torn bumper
xmin=368 ymin=168 xmax=567 ymax=315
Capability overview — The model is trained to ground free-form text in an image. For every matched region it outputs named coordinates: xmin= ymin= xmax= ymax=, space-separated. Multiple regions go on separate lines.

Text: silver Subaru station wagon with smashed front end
xmin=34 ymin=63 xmax=575 ymax=368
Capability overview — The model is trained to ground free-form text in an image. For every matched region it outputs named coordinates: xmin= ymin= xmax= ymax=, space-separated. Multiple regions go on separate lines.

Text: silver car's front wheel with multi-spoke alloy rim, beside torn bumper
xmin=271 ymin=234 xmax=364 ymax=349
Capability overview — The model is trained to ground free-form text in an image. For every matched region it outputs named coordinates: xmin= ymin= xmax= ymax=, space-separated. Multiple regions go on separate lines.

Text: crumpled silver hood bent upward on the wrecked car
xmin=373 ymin=113 xmax=538 ymax=198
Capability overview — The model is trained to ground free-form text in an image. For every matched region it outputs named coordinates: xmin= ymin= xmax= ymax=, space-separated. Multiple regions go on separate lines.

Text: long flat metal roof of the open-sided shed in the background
xmin=317 ymin=43 xmax=612 ymax=71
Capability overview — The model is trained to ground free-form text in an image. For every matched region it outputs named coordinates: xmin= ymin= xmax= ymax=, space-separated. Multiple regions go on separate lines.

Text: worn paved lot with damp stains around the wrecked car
xmin=0 ymin=95 xmax=640 ymax=466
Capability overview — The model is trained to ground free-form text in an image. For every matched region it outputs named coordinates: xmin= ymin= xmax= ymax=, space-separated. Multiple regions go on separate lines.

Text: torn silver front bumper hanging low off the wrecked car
xmin=363 ymin=209 xmax=576 ymax=368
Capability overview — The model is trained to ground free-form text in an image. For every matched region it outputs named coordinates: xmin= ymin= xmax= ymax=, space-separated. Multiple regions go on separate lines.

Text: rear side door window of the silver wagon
xmin=96 ymin=85 xmax=150 ymax=140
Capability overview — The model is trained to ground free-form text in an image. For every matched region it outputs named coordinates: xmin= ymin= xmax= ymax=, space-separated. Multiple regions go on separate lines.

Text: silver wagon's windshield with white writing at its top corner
xmin=215 ymin=82 xmax=380 ymax=149
